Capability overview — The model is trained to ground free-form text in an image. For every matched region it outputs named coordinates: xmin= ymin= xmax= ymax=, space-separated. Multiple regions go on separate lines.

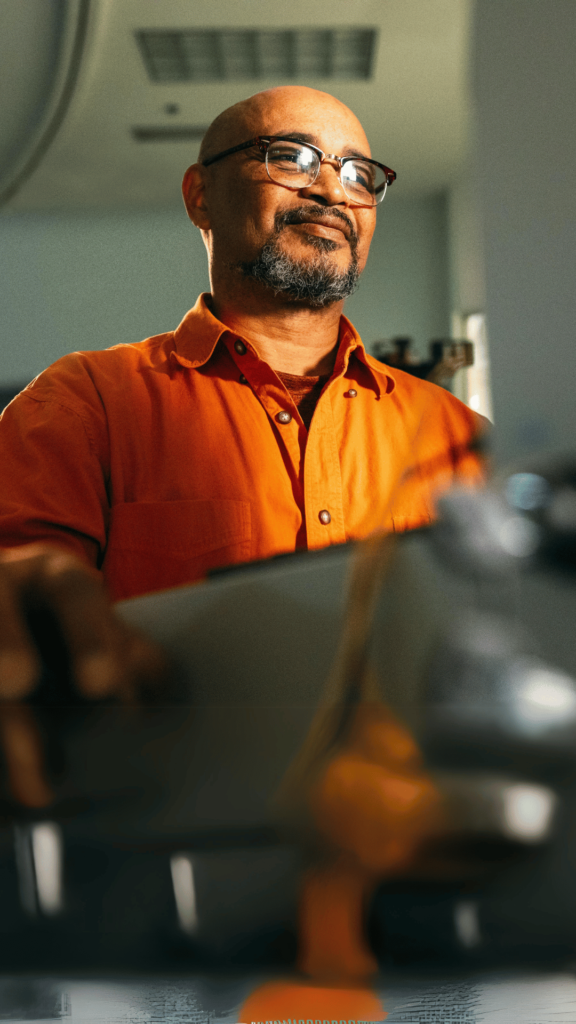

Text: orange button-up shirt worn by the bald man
xmin=0 ymin=296 xmax=481 ymax=599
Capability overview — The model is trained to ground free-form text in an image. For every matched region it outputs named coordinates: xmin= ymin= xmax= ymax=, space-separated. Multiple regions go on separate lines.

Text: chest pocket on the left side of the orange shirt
xmin=102 ymin=499 xmax=251 ymax=600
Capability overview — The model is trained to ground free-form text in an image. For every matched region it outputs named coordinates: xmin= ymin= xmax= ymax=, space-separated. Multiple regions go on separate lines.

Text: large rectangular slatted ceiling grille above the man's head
xmin=135 ymin=29 xmax=376 ymax=82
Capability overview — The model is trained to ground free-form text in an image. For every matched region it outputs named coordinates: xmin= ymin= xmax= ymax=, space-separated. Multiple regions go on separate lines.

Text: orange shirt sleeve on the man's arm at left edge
xmin=0 ymin=372 xmax=109 ymax=567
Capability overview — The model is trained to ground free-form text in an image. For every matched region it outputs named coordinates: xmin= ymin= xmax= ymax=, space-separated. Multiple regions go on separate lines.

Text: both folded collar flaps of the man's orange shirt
xmin=172 ymin=292 xmax=395 ymax=394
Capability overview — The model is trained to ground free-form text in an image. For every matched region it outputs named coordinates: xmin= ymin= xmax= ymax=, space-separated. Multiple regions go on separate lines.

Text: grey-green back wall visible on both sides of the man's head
xmin=0 ymin=186 xmax=449 ymax=387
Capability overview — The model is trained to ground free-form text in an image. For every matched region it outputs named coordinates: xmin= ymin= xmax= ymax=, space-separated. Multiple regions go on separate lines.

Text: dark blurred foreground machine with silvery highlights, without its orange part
xmin=0 ymin=463 xmax=576 ymax=972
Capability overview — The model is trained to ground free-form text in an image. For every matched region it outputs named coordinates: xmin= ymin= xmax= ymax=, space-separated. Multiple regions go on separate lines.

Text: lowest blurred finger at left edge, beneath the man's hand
xmin=0 ymin=705 xmax=53 ymax=807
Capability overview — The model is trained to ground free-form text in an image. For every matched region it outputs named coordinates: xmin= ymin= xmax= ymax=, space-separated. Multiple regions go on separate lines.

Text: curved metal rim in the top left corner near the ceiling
xmin=0 ymin=0 xmax=90 ymax=206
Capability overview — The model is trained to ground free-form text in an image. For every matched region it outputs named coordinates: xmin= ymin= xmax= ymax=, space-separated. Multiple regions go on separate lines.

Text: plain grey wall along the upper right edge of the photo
xmin=471 ymin=0 xmax=576 ymax=463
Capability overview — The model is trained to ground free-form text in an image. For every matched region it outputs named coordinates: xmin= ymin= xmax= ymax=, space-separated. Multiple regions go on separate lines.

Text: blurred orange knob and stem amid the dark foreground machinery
xmin=298 ymin=703 xmax=445 ymax=980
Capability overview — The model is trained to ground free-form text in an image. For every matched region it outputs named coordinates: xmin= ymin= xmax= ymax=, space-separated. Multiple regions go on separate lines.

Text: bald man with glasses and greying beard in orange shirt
xmin=0 ymin=87 xmax=480 ymax=803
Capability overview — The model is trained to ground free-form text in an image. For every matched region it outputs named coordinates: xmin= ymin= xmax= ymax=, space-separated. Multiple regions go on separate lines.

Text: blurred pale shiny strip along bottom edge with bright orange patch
xmin=0 ymin=973 xmax=576 ymax=1024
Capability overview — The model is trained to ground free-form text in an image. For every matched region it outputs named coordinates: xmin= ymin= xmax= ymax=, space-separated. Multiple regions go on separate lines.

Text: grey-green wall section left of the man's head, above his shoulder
xmin=0 ymin=208 xmax=208 ymax=385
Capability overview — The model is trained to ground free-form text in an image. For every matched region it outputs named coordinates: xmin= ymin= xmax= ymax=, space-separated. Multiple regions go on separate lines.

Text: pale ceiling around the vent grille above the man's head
xmin=0 ymin=0 xmax=471 ymax=212
